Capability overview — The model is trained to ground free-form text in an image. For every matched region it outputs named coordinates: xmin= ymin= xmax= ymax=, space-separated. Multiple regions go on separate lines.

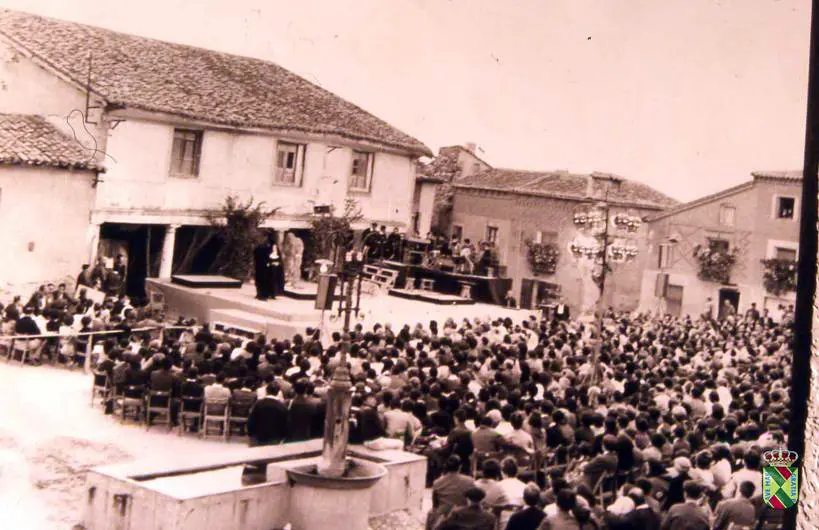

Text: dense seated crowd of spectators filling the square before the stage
xmin=3 ymin=278 xmax=793 ymax=530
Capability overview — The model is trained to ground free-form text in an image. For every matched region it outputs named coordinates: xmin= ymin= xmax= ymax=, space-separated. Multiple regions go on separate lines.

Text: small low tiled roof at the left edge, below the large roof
xmin=0 ymin=114 xmax=102 ymax=171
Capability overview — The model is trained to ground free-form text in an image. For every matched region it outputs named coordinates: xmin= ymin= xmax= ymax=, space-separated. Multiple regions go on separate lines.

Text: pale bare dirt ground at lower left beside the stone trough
xmin=0 ymin=361 xmax=428 ymax=530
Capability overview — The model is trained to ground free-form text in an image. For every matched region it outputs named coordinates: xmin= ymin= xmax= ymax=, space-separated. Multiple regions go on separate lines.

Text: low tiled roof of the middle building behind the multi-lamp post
xmin=455 ymin=169 xmax=679 ymax=209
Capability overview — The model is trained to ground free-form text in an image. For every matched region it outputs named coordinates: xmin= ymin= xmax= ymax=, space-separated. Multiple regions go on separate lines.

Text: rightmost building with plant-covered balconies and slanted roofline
xmin=640 ymin=172 xmax=802 ymax=317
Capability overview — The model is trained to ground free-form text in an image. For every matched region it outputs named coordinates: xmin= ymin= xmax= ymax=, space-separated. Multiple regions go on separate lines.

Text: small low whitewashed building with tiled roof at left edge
xmin=0 ymin=114 xmax=101 ymax=291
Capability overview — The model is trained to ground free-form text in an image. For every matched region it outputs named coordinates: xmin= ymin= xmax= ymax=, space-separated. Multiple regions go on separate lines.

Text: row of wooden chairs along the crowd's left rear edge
xmin=91 ymin=372 xmax=255 ymax=441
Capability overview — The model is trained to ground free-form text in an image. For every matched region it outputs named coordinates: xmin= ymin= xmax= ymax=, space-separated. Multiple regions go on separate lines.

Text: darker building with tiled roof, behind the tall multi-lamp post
xmin=450 ymin=169 xmax=676 ymax=311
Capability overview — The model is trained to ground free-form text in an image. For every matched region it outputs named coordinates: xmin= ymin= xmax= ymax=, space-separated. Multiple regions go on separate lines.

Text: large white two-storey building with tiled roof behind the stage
xmin=0 ymin=10 xmax=431 ymax=292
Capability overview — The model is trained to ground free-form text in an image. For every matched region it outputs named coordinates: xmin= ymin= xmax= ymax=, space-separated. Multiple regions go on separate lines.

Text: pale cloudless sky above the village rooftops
xmin=0 ymin=0 xmax=810 ymax=200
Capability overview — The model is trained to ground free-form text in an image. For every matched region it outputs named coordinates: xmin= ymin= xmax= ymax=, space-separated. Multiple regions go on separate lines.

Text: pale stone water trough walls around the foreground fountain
xmin=83 ymin=440 xmax=426 ymax=530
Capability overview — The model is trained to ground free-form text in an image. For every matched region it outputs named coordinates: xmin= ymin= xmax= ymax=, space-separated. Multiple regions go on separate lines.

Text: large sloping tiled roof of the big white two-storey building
xmin=0 ymin=9 xmax=432 ymax=156
